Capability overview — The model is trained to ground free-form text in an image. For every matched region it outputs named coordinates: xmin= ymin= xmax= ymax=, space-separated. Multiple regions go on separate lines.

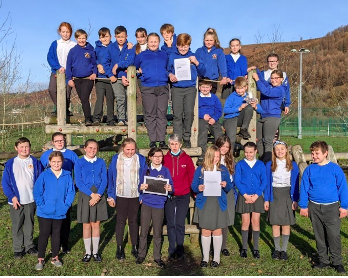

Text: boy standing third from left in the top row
xmin=93 ymin=27 xmax=115 ymax=126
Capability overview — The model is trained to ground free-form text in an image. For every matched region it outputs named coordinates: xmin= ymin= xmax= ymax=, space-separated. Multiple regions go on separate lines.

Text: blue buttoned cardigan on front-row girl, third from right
xmin=234 ymin=159 xmax=267 ymax=196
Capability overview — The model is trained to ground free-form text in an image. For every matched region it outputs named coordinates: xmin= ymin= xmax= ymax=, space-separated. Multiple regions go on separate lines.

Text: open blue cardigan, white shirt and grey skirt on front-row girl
xmin=264 ymin=159 xmax=300 ymax=226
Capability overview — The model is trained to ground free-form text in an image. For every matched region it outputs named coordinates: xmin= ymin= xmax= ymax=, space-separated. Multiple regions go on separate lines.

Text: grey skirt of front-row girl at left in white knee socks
xmin=77 ymin=185 xmax=108 ymax=223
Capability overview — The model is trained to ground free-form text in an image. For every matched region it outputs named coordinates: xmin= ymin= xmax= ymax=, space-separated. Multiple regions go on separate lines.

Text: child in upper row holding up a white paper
xmin=167 ymin=33 xmax=205 ymax=148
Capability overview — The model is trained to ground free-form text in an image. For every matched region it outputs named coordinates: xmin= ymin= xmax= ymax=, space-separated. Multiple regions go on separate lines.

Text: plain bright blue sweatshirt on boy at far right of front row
xmin=299 ymin=161 xmax=348 ymax=209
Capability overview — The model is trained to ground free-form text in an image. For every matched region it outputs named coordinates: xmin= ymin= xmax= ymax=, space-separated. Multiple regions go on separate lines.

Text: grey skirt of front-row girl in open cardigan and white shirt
xmin=267 ymin=187 xmax=296 ymax=226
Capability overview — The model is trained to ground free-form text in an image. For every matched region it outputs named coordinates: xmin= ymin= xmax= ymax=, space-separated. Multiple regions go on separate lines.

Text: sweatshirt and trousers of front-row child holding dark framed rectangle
xmin=138 ymin=165 xmax=174 ymax=261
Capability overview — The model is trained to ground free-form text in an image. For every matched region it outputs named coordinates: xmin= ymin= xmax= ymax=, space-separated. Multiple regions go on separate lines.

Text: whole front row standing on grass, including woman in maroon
xmin=2 ymin=133 xmax=348 ymax=273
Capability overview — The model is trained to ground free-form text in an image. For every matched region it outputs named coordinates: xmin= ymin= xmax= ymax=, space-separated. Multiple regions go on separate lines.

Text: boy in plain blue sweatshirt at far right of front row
xmin=299 ymin=141 xmax=348 ymax=273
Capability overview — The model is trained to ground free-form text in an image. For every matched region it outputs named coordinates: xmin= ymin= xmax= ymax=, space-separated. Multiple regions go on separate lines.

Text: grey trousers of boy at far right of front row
xmin=308 ymin=202 xmax=342 ymax=265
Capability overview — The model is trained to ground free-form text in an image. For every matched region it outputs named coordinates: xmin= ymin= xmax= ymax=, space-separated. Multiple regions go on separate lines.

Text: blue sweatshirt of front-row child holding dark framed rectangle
xmin=139 ymin=165 xmax=174 ymax=209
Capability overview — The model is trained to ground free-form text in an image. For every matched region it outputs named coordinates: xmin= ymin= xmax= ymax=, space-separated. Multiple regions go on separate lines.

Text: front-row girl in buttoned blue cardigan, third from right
xmin=234 ymin=142 xmax=267 ymax=259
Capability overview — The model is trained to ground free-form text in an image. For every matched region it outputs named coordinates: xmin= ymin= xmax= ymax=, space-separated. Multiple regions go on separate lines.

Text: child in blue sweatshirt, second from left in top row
xmin=66 ymin=29 xmax=97 ymax=126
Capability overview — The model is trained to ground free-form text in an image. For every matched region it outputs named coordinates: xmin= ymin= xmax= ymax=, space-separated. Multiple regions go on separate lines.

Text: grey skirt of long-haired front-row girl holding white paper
xmin=193 ymin=196 xmax=230 ymax=231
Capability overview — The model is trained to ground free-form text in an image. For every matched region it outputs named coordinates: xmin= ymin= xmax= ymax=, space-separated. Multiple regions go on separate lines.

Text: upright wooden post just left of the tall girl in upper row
xmin=127 ymin=66 xmax=137 ymax=141
